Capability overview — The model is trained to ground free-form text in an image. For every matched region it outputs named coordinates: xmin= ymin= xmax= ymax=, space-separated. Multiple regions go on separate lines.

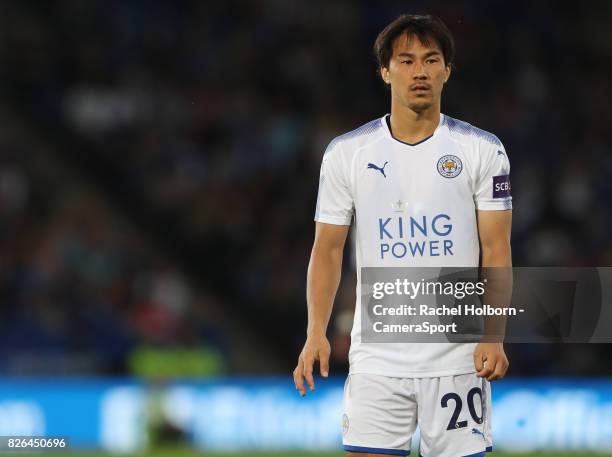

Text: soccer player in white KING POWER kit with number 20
xmin=293 ymin=15 xmax=512 ymax=457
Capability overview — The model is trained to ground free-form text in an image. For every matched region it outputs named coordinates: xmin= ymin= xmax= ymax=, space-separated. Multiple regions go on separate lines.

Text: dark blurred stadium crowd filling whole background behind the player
xmin=0 ymin=0 xmax=612 ymax=375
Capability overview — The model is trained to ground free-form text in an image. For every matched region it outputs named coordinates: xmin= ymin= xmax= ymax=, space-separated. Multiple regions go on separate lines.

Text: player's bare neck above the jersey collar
xmin=390 ymin=104 xmax=440 ymax=144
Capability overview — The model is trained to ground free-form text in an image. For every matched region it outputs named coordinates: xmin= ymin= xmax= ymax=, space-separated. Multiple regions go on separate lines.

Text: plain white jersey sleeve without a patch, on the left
xmin=315 ymin=141 xmax=354 ymax=225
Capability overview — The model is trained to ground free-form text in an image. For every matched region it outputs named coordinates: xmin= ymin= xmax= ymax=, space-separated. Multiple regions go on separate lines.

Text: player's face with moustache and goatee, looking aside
xmin=380 ymin=33 xmax=450 ymax=113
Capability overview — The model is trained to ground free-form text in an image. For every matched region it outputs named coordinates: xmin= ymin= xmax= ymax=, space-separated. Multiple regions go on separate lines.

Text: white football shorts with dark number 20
xmin=342 ymin=373 xmax=492 ymax=457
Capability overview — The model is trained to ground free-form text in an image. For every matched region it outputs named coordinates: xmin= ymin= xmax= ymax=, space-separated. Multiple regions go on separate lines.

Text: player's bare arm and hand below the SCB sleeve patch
xmin=474 ymin=210 xmax=512 ymax=381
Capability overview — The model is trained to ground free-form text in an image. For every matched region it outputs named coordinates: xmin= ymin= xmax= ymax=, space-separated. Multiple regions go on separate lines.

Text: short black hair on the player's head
xmin=374 ymin=14 xmax=455 ymax=68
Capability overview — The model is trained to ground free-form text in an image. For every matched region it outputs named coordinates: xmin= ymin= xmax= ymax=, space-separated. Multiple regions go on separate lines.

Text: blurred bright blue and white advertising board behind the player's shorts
xmin=0 ymin=377 xmax=612 ymax=453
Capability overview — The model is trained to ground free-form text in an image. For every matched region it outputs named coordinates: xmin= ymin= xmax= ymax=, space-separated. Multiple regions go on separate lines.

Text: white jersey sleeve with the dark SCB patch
xmin=474 ymin=138 xmax=512 ymax=211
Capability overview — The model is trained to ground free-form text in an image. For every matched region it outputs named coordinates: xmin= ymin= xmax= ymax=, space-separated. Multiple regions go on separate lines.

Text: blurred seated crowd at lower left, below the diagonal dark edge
xmin=0 ymin=134 xmax=233 ymax=374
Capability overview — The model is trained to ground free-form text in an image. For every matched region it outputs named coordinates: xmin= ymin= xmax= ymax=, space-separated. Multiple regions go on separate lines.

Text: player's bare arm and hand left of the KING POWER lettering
xmin=293 ymin=222 xmax=349 ymax=396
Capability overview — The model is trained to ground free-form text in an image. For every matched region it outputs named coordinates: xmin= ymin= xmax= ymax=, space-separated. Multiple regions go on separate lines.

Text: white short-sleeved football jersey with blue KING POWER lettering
xmin=315 ymin=114 xmax=512 ymax=377
